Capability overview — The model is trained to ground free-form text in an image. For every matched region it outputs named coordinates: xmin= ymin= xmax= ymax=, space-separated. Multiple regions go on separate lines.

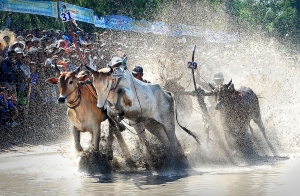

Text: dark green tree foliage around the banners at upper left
xmin=0 ymin=0 xmax=163 ymax=31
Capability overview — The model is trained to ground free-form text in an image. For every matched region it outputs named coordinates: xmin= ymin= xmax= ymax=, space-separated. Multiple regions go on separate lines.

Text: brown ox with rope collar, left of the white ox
xmin=46 ymin=66 xmax=133 ymax=166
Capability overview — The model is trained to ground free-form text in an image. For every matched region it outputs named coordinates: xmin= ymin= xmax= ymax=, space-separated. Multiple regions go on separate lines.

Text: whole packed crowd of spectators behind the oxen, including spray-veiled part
xmin=0 ymin=16 xmax=192 ymax=132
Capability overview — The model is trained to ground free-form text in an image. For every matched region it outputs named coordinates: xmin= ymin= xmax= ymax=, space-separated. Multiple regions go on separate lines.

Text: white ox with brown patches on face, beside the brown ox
xmin=87 ymin=65 xmax=199 ymax=161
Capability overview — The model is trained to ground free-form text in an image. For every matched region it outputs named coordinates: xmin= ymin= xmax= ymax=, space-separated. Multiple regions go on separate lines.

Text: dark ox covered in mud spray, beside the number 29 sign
xmin=214 ymin=80 xmax=276 ymax=157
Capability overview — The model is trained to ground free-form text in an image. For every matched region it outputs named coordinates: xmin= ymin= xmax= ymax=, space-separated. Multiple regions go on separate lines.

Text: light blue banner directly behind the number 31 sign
xmin=58 ymin=1 xmax=94 ymax=24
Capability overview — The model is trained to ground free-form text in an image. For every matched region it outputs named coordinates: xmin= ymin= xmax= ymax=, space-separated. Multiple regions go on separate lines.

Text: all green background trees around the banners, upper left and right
xmin=0 ymin=0 xmax=300 ymax=49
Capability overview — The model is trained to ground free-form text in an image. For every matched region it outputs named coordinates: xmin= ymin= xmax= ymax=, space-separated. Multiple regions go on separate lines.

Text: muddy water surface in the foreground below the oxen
xmin=0 ymin=145 xmax=300 ymax=196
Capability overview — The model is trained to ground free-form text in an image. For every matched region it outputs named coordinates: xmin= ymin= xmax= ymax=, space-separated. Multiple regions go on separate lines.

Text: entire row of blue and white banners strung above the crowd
xmin=0 ymin=0 xmax=239 ymax=43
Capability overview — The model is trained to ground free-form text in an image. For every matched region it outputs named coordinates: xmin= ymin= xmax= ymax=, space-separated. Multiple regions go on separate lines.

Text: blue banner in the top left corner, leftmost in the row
xmin=0 ymin=0 xmax=58 ymax=18
